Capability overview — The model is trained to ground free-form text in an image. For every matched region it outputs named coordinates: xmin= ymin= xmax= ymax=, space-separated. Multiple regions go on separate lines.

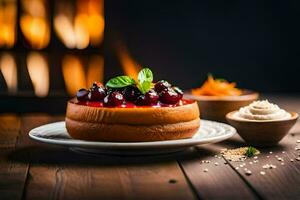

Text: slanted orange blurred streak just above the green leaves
xmin=116 ymin=45 xmax=141 ymax=79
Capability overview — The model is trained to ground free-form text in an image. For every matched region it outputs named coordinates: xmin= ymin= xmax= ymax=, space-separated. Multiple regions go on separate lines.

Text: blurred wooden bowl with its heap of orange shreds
xmin=185 ymin=75 xmax=259 ymax=122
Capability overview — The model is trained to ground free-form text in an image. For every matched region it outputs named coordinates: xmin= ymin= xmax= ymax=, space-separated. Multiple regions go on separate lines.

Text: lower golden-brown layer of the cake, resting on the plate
xmin=66 ymin=118 xmax=200 ymax=142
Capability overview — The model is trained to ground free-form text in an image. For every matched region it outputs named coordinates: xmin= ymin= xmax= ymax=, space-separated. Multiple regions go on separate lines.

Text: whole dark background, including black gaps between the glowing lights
xmin=0 ymin=0 xmax=300 ymax=113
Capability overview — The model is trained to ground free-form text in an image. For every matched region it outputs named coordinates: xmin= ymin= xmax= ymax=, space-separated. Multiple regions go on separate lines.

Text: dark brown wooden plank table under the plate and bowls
xmin=0 ymin=97 xmax=300 ymax=200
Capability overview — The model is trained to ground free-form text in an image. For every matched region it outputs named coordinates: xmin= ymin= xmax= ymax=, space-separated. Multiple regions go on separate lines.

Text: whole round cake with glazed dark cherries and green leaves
xmin=66 ymin=68 xmax=200 ymax=142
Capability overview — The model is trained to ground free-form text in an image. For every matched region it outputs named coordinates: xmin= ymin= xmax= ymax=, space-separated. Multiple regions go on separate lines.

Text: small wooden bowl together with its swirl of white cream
xmin=226 ymin=100 xmax=298 ymax=146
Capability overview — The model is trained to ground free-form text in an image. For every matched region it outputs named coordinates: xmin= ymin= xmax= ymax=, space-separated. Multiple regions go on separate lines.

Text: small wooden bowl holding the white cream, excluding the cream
xmin=226 ymin=111 xmax=298 ymax=146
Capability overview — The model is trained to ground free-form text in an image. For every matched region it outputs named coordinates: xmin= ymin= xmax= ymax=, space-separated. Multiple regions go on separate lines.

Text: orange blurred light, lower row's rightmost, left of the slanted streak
xmin=87 ymin=56 xmax=104 ymax=86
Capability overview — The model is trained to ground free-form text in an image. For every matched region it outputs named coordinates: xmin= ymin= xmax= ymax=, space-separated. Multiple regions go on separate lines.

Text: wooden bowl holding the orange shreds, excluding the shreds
xmin=185 ymin=90 xmax=259 ymax=122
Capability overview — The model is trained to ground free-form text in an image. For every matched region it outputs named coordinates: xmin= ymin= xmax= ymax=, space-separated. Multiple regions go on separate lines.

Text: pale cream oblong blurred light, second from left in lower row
xmin=27 ymin=52 xmax=50 ymax=97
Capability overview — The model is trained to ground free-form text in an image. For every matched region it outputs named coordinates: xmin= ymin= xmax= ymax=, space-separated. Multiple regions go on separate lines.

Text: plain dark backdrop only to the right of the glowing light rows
xmin=105 ymin=0 xmax=300 ymax=93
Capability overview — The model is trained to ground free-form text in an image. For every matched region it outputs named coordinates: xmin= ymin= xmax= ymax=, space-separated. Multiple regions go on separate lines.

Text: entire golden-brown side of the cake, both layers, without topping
xmin=66 ymin=102 xmax=200 ymax=142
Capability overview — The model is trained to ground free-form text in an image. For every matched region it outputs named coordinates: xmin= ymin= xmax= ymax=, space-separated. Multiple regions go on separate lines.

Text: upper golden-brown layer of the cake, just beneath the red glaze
xmin=66 ymin=102 xmax=199 ymax=125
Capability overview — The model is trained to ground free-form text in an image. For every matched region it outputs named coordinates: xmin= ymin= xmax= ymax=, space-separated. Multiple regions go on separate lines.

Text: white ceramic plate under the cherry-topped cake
xmin=29 ymin=120 xmax=236 ymax=155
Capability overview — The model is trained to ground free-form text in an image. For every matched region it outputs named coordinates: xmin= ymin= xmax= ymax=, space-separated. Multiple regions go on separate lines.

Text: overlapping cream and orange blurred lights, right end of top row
xmin=54 ymin=0 xmax=105 ymax=49
